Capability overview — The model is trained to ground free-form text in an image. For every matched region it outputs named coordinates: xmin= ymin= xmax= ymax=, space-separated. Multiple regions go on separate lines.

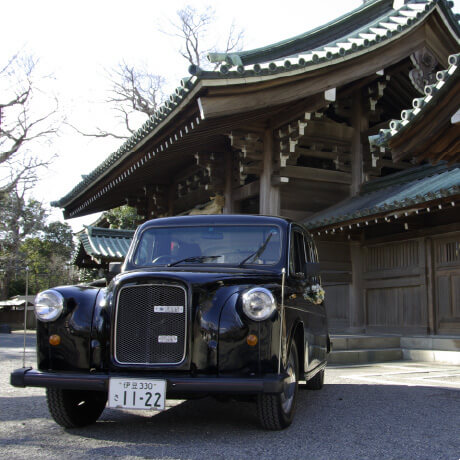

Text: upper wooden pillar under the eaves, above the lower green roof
xmin=351 ymin=89 xmax=369 ymax=196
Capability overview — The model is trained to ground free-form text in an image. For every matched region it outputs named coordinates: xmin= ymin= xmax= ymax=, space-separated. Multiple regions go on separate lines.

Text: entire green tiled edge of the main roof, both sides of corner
xmin=51 ymin=0 xmax=460 ymax=207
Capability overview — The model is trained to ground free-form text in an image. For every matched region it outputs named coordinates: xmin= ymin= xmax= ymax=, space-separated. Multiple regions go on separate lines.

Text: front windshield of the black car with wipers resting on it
xmin=133 ymin=225 xmax=281 ymax=267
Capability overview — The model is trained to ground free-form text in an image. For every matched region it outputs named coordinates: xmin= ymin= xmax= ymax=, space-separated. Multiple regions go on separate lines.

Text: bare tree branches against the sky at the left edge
xmin=0 ymin=54 xmax=58 ymax=193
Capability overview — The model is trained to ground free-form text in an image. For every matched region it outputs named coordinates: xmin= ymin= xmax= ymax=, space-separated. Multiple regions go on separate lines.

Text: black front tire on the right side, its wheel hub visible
xmin=257 ymin=342 xmax=299 ymax=430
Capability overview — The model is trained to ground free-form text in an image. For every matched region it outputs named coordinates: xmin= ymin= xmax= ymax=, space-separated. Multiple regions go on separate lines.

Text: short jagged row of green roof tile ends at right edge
xmin=369 ymin=53 xmax=460 ymax=147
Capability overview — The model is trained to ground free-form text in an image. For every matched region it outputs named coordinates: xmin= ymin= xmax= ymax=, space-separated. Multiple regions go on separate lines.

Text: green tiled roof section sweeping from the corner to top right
xmin=207 ymin=0 xmax=460 ymax=78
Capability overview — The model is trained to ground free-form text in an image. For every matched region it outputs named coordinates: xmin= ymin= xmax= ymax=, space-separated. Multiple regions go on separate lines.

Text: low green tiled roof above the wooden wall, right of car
xmin=305 ymin=163 xmax=460 ymax=229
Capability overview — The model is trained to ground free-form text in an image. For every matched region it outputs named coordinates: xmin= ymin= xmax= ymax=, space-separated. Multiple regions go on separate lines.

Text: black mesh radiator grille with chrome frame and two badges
xmin=114 ymin=284 xmax=187 ymax=365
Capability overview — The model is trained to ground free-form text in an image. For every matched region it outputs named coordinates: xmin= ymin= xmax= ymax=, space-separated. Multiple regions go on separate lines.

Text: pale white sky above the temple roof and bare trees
xmin=0 ymin=0 xmax=460 ymax=231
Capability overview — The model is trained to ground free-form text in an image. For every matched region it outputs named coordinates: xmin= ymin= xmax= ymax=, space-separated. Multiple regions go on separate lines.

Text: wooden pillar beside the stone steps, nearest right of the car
xmin=349 ymin=241 xmax=366 ymax=332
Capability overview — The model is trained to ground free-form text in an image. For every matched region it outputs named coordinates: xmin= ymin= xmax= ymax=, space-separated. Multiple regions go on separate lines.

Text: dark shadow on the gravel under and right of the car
xmin=55 ymin=384 xmax=460 ymax=458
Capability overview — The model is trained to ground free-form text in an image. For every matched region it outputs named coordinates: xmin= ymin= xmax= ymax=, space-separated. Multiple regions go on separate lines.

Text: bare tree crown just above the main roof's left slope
xmin=70 ymin=62 xmax=165 ymax=139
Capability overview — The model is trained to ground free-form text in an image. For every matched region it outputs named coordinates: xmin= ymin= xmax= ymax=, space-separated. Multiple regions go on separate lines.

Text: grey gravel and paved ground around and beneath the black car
xmin=0 ymin=333 xmax=460 ymax=460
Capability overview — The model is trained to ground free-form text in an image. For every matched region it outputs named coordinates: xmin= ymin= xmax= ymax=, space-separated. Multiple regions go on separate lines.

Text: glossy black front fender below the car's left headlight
xmin=37 ymin=286 xmax=100 ymax=370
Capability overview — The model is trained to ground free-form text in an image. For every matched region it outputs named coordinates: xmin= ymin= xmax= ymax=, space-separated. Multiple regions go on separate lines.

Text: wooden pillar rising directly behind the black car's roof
xmin=259 ymin=128 xmax=280 ymax=216
